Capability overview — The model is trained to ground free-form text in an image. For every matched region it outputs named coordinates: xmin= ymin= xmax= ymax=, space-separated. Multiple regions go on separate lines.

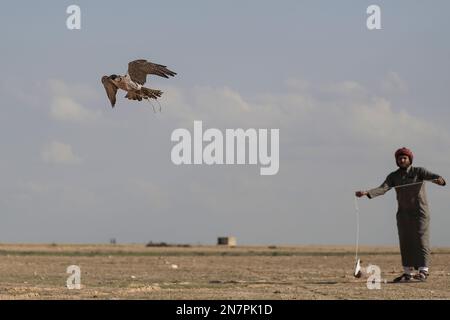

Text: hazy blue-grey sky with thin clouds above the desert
xmin=0 ymin=0 xmax=450 ymax=246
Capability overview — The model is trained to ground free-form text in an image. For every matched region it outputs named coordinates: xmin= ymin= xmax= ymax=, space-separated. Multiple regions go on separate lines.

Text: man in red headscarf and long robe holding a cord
xmin=356 ymin=148 xmax=446 ymax=282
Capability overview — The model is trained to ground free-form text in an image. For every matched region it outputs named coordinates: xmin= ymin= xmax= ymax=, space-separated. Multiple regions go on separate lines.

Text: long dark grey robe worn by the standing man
xmin=367 ymin=166 xmax=440 ymax=269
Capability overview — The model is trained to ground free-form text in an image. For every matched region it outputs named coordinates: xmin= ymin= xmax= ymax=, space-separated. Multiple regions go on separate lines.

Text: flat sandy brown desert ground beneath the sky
xmin=0 ymin=244 xmax=450 ymax=299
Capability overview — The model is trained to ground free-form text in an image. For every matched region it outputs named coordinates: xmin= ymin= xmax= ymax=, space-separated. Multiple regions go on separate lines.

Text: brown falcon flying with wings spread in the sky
xmin=102 ymin=60 xmax=176 ymax=108
